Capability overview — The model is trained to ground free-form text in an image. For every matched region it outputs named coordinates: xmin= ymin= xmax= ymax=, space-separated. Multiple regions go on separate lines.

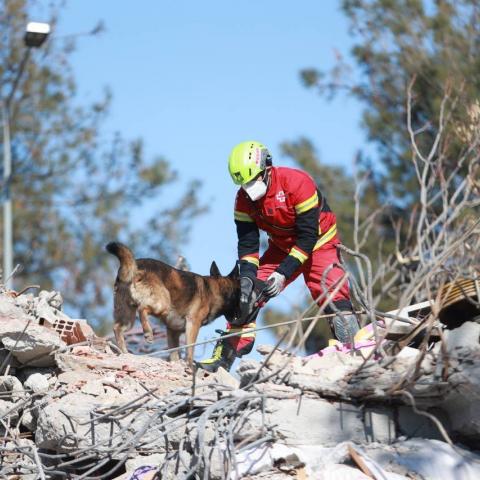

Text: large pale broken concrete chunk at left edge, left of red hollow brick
xmin=0 ymin=314 xmax=65 ymax=367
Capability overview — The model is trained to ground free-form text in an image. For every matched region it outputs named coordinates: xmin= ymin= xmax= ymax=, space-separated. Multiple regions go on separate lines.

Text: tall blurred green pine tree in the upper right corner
xmin=302 ymin=0 xmax=480 ymax=206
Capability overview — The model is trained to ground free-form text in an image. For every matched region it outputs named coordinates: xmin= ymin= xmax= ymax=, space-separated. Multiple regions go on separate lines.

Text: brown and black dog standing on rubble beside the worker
xmin=106 ymin=242 xmax=240 ymax=365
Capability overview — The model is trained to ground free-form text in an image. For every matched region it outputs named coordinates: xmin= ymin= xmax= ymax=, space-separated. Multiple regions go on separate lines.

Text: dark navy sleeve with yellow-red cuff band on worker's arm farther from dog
xmin=277 ymin=207 xmax=320 ymax=279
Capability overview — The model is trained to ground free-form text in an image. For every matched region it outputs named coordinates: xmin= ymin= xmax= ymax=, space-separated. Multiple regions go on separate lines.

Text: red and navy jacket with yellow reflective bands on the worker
xmin=234 ymin=167 xmax=339 ymax=278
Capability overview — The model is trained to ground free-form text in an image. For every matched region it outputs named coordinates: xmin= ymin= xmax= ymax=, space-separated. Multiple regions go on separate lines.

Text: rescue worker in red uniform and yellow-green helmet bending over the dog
xmin=197 ymin=141 xmax=359 ymax=371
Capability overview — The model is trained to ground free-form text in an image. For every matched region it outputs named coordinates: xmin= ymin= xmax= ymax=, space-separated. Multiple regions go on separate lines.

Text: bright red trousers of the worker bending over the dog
xmin=257 ymin=242 xmax=350 ymax=303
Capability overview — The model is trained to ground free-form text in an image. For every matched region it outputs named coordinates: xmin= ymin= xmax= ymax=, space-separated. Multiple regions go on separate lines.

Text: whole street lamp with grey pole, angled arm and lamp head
xmin=1 ymin=22 xmax=50 ymax=289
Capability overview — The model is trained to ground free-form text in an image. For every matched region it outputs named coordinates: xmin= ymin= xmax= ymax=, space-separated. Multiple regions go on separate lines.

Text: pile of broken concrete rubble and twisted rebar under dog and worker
xmin=0 ymin=292 xmax=480 ymax=480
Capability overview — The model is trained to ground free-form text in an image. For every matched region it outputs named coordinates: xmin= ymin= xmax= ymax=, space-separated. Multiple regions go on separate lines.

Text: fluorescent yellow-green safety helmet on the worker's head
xmin=228 ymin=141 xmax=271 ymax=185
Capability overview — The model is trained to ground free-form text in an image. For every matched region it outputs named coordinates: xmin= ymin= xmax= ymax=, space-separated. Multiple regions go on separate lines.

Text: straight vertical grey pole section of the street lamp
xmin=2 ymin=102 xmax=13 ymax=289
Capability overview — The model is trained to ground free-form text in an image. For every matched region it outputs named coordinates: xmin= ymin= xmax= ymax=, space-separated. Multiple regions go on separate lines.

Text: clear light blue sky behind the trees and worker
xmin=54 ymin=0 xmax=364 ymax=360
